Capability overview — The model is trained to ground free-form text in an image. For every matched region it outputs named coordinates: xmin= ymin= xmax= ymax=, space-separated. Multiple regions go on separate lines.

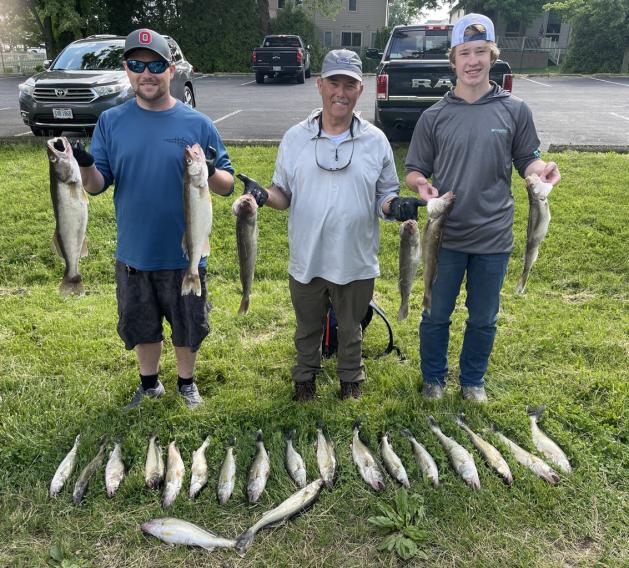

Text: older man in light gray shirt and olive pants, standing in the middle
xmin=238 ymin=49 xmax=420 ymax=402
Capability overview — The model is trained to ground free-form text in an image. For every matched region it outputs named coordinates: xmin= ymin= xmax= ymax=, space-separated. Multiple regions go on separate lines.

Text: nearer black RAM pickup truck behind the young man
xmin=367 ymin=25 xmax=513 ymax=138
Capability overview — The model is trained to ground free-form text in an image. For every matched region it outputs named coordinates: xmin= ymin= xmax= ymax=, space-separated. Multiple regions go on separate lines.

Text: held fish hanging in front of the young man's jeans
xmin=422 ymin=191 xmax=455 ymax=314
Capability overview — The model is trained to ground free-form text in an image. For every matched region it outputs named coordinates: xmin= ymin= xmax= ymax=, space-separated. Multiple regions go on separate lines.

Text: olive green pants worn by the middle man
xmin=289 ymin=276 xmax=375 ymax=383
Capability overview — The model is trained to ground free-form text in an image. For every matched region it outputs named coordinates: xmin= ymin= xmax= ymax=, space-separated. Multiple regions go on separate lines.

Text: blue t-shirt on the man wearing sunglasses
xmin=90 ymin=99 xmax=234 ymax=270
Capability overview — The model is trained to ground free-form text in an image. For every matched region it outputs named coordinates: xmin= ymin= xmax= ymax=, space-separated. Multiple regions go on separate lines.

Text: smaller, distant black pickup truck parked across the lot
xmin=251 ymin=35 xmax=310 ymax=83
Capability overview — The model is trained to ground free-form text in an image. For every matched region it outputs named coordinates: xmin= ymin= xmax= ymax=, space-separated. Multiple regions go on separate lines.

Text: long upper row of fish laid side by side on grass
xmin=49 ymin=407 xmax=571 ymax=508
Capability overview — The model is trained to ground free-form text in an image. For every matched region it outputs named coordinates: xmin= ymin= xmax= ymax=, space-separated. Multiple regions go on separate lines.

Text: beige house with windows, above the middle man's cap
xmin=269 ymin=0 xmax=392 ymax=52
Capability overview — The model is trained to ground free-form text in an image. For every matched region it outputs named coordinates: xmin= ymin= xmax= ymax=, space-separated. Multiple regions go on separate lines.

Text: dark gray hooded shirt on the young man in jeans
xmin=406 ymin=84 xmax=540 ymax=254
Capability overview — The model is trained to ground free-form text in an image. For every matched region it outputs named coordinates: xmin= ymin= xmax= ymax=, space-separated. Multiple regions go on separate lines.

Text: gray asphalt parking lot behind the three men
xmin=0 ymin=75 xmax=629 ymax=150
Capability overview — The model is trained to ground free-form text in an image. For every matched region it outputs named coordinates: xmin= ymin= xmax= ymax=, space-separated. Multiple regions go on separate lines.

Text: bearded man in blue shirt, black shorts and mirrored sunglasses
xmin=74 ymin=29 xmax=234 ymax=408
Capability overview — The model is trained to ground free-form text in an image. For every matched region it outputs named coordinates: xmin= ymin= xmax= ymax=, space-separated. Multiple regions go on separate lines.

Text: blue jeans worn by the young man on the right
xmin=419 ymin=248 xmax=510 ymax=387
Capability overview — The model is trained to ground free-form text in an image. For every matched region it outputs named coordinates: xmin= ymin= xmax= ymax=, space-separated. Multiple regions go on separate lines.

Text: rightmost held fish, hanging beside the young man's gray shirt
xmin=515 ymin=174 xmax=553 ymax=294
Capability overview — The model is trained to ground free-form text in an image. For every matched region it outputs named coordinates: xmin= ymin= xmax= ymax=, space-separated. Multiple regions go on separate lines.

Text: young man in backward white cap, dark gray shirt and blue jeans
xmin=406 ymin=14 xmax=560 ymax=402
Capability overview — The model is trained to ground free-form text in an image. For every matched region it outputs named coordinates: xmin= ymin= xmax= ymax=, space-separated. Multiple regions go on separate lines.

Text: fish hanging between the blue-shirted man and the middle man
xmin=232 ymin=194 xmax=258 ymax=315
